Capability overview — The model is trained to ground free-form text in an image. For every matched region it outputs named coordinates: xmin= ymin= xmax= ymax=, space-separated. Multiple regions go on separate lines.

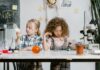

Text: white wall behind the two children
xmin=20 ymin=0 xmax=95 ymax=70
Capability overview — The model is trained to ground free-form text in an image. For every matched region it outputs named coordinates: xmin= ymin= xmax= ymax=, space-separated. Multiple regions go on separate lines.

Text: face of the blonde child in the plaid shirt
xmin=26 ymin=22 xmax=37 ymax=36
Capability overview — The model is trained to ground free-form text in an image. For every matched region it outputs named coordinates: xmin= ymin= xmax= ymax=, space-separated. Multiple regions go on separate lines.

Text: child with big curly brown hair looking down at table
xmin=43 ymin=17 xmax=70 ymax=70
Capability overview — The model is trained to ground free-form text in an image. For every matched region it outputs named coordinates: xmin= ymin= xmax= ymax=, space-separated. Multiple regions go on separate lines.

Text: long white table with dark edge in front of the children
xmin=0 ymin=51 xmax=100 ymax=62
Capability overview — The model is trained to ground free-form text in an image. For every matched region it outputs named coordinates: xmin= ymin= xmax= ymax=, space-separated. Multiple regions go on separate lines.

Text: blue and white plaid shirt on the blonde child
xmin=17 ymin=35 xmax=42 ymax=49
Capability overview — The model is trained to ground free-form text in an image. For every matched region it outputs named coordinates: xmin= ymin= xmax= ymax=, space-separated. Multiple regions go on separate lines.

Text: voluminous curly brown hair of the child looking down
xmin=45 ymin=17 xmax=69 ymax=37
